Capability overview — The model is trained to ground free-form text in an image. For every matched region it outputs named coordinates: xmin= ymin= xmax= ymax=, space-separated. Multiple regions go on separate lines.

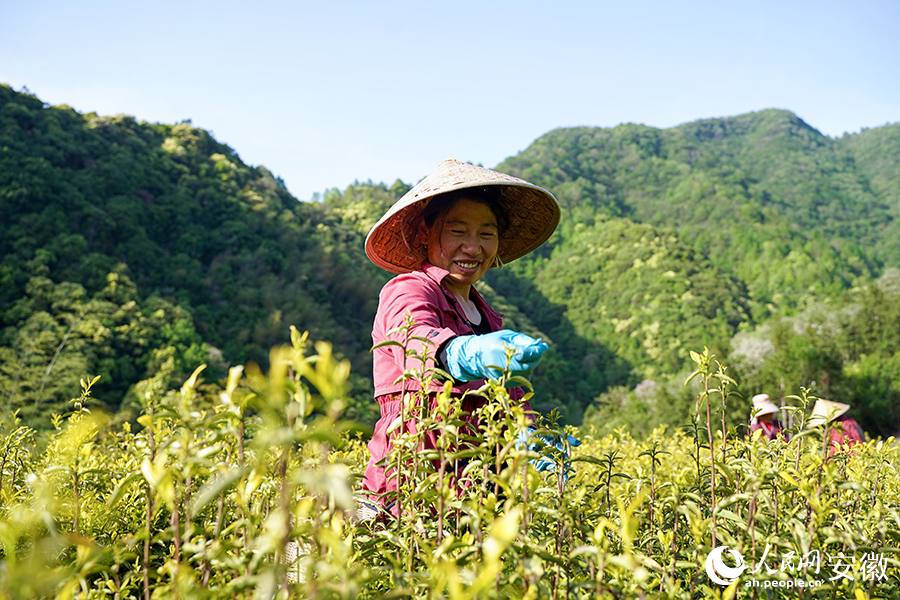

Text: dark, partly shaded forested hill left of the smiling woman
xmin=0 ymin=86 xmax=388 ymax=424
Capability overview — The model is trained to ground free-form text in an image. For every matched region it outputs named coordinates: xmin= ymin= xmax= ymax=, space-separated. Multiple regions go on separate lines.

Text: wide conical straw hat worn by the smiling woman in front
xmin=366 ymin=159 xmax=560 ymax=274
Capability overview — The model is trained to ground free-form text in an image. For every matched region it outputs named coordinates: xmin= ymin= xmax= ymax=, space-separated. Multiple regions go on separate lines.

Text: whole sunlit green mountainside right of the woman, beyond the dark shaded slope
xmin=490 ymin=110 xmax=900 ymax=434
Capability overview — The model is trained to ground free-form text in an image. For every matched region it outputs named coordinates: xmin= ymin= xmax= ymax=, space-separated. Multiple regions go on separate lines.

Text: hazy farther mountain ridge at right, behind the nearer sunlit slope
xmin=499 ymin=110 xmax=900 ymax=307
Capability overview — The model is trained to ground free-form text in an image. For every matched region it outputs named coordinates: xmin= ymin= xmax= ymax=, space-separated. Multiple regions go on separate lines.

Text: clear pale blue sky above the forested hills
xmin=0 ymin=0 xmax=900 ymax=200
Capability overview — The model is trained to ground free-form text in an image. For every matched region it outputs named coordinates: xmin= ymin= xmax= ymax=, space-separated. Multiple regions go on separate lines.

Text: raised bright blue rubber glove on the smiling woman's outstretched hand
xmin=444 ymin=329 xmax=548 ymax=381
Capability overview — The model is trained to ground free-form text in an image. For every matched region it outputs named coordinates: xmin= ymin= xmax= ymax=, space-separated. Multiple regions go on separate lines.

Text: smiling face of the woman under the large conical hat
xmin=428 ymin=198 xmax=500 ymax=297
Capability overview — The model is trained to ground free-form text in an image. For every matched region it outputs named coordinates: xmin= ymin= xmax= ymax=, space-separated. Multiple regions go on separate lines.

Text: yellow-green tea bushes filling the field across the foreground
xmin=0 ymin=330 xmax=900 ymax=600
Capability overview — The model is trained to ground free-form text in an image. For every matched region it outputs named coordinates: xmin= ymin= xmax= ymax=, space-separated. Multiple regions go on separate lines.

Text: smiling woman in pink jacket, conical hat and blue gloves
xmin=363 ymin=160 xmax=560 ymax=515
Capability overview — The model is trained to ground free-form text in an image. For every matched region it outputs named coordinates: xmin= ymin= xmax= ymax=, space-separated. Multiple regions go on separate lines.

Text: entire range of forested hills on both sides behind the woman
xmin=0 ymin=86 xmax=900 ymax=436
